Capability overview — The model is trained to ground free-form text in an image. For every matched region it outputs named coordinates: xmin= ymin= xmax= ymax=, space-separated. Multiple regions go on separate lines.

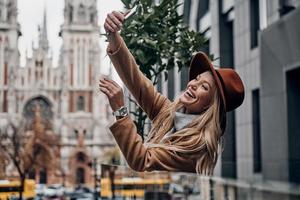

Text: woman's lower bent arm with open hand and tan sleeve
xmin=99 ymin=79 xmax=195 ymax=172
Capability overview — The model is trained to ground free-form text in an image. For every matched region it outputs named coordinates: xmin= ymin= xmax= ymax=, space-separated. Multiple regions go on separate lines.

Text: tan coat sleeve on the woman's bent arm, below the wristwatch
xmin=110 ymin=116 xmax=195 ymax=172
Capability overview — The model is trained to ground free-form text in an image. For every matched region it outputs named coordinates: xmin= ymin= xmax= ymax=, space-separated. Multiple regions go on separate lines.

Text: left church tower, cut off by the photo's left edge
xmin=0 ymin=0 xmax=21 ymax=114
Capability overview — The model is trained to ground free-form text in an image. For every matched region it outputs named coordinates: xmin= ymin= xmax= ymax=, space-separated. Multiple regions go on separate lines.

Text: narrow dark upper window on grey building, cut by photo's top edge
xmin=250 ymin=0 xmax=260 ymax=49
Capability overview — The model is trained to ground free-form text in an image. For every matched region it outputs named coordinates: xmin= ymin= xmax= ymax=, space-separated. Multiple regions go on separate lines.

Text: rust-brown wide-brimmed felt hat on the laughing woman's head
xmin=189 ymin=52 xmax=245 ymax=112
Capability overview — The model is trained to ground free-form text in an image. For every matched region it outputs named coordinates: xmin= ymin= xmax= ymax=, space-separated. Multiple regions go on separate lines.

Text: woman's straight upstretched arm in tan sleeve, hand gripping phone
xmin=104 ymin=12 xmax=170 ymax=120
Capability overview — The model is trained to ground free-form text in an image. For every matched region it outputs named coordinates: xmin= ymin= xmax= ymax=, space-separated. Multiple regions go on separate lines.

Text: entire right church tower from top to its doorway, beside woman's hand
xmin=60 ymin=0 xmax=114 ymax=183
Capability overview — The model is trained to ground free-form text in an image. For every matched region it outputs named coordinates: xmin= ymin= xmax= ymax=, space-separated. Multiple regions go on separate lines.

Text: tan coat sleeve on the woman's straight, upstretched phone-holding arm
xmin=107 ymin=36 xmax=170 ymax=120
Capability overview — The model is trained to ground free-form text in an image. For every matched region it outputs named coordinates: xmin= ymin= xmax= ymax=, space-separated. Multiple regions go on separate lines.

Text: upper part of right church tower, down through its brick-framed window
xmin=60 ymin=0 xmax=100 ymax=114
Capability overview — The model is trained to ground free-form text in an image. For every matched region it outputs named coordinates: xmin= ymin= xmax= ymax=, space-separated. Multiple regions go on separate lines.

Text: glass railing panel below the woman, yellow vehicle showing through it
xmin=101 ymin=165 xmax=300 ymax=200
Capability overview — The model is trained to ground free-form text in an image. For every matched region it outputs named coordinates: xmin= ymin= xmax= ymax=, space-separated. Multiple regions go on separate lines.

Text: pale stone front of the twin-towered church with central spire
xmin=0 ymin=0 xmax=115 ymax=184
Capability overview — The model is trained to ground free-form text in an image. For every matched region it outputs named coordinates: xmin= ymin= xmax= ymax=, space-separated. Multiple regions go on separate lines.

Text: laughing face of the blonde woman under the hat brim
xmin=179 ymin=71 xmax=216 ymax=114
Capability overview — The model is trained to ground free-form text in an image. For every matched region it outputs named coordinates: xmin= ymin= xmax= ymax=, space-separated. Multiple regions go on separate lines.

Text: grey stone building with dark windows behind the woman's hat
xmin=183 ymin=0 xmax=300 ymax=183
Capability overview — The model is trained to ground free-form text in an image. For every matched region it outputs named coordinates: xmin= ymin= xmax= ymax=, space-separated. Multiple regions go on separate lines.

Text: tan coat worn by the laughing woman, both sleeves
xmin=107 ymin=36 xmax=196 ymax=172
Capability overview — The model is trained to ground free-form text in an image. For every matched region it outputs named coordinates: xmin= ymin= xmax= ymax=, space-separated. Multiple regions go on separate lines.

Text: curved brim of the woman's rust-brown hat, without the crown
xmin=189 ymin=52 xmax=226 ymax=110
